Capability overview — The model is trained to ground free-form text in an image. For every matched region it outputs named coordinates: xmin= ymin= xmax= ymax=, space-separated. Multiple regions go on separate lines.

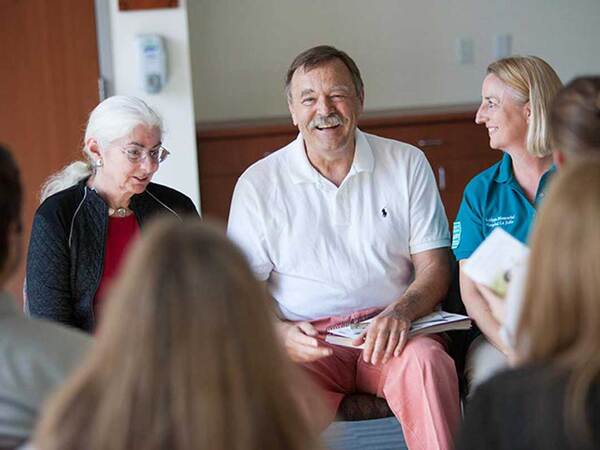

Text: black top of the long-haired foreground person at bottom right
xmin=456 ymin=365 xmax=600 ymax=450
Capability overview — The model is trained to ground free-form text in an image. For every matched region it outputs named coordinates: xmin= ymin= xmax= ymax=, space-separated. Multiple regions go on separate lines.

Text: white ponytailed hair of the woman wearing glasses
xmin=40 ymin=95 xmax=163 ymax=202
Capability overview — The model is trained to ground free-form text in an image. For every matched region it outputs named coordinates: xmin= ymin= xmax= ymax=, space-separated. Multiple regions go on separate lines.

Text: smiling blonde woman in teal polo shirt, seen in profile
xmin=452 ymin=56 xmax=562 ymax=390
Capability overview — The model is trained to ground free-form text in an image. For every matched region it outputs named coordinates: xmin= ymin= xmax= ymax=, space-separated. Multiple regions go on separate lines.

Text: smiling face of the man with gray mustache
xmin=288 ymin=59 xmax=363 ymax=160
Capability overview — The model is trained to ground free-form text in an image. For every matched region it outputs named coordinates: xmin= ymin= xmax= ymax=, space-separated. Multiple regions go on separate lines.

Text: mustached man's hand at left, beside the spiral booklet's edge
xmin=277 ymin=322 xmax=333 ymax=363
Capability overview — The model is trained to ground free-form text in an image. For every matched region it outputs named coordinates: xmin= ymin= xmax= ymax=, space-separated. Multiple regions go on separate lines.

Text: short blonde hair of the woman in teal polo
xmin=487 ymin=56 xmax=562 ymax=157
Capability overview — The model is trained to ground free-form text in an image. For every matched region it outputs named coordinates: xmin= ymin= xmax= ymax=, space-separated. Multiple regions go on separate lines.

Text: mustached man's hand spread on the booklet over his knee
xmin=352 ymin=309 xmax=411 ymax=365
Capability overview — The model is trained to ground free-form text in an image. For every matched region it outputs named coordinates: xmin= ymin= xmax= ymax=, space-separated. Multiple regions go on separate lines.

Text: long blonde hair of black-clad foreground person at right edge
xmin=517 ymin=161 xmax=600 ymax=442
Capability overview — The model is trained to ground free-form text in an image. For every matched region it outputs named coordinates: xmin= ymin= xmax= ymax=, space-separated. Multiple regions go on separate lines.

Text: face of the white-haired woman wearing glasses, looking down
xmin=90 ymin=125 xmax=161 ymax=199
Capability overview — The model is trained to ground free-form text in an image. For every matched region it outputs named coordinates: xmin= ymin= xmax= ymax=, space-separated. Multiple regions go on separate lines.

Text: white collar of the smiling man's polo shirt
xmin=290 ymin=128 xmax=375 ymax=184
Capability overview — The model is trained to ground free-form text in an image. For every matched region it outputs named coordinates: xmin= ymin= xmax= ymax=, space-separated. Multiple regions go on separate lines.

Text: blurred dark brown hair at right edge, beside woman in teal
xmin=550 ymin=76 xmax=600 ymax=160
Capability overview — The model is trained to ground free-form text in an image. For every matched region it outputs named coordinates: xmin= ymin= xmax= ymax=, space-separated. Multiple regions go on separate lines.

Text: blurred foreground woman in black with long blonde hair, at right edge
xmin=458 ymin=159 xmax=600 ymax=450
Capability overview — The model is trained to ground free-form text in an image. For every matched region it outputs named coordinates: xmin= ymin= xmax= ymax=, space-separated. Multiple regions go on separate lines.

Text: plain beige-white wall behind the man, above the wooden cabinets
xmin=188 ymin=0 xmax=600 ymax=121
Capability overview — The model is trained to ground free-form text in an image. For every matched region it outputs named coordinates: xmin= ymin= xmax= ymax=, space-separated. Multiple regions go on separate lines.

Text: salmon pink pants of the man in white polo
xmin=303 ymin=312 xmax=460 ymax=450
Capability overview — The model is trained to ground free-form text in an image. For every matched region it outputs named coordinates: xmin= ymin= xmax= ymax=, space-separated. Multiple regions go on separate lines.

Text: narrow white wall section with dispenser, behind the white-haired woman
xmin=108 ymin=0 xmax=200 ymax=207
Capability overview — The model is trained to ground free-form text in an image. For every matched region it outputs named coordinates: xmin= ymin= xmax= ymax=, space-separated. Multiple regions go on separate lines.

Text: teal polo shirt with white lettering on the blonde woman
xmin=452 ymin=153 xmax=556 ymax=260
